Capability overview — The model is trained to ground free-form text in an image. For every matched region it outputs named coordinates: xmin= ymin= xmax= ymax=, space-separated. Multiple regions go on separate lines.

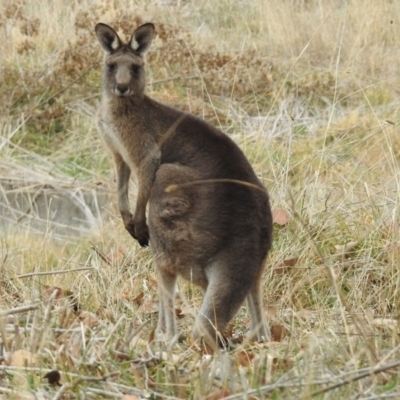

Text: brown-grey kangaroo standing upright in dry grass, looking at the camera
xmin=95 ymin=23 xmax=272 ymax=350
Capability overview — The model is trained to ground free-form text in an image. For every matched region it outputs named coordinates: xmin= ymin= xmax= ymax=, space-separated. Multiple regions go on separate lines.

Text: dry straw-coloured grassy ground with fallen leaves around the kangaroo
xmin=0 ymin=0 xmax=400 ymax=400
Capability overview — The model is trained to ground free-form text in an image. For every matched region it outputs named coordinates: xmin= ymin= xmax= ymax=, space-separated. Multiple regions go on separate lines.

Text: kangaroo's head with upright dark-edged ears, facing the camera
xmin=95 ymin=23 xmax=155 ymax=98
